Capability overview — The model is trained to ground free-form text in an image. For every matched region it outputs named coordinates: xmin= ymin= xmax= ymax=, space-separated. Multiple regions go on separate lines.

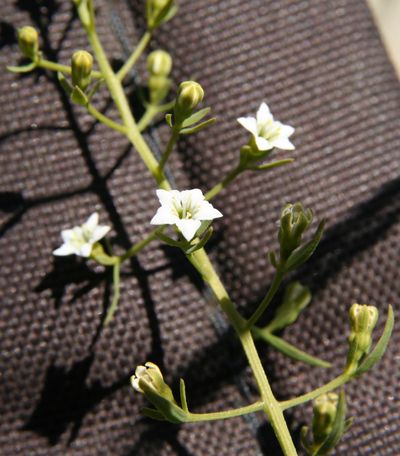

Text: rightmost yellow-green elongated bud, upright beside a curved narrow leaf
xmin=346 ymin=304 xmax=379 ymax=371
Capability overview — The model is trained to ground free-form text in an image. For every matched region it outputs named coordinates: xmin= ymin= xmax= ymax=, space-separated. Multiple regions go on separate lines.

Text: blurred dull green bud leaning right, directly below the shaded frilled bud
xmin=266 ymin=282 xmax=311 ymax=333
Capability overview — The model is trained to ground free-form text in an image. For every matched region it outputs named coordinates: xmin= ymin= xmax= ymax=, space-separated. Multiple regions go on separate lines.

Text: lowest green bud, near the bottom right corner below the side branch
xmin=312 ymin=393 xmax=339 ymax=445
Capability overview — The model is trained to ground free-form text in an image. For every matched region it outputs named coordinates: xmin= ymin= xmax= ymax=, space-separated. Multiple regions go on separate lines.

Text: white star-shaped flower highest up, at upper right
xmin=237 ymin=103 xmax=295 ymax=151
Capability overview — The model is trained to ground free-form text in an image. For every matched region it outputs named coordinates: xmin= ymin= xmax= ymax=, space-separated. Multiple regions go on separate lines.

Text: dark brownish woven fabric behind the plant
xmin=0 ymin=0 xmax=400 ymax=456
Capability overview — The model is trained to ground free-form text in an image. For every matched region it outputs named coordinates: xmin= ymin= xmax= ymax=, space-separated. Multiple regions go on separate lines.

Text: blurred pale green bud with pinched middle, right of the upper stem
xmin=147 ymin=49 xmax=172 ymax=105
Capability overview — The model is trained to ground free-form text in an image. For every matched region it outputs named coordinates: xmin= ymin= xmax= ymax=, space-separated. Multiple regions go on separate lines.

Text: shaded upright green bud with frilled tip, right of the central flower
xmin=278 ymin=203 xmax=313 ymax=261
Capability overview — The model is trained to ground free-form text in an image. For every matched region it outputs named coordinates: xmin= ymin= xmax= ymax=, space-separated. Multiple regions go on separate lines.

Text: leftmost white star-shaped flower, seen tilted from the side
xmin=53 ymin=212 xmax=110 ymax=258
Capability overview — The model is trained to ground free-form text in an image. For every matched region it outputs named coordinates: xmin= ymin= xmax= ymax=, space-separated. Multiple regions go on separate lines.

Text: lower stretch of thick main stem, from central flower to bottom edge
xmin=188 ymin=249 xmax=297 ymax=456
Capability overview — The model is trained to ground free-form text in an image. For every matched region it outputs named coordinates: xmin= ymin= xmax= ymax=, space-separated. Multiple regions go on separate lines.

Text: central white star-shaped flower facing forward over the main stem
xmin=150 ymin=188 xmax=222 ymax=241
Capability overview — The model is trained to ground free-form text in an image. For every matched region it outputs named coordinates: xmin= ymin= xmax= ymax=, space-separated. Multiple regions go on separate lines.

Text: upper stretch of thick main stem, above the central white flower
xmin=87 ymin=20 xmax=171 ymax=190
